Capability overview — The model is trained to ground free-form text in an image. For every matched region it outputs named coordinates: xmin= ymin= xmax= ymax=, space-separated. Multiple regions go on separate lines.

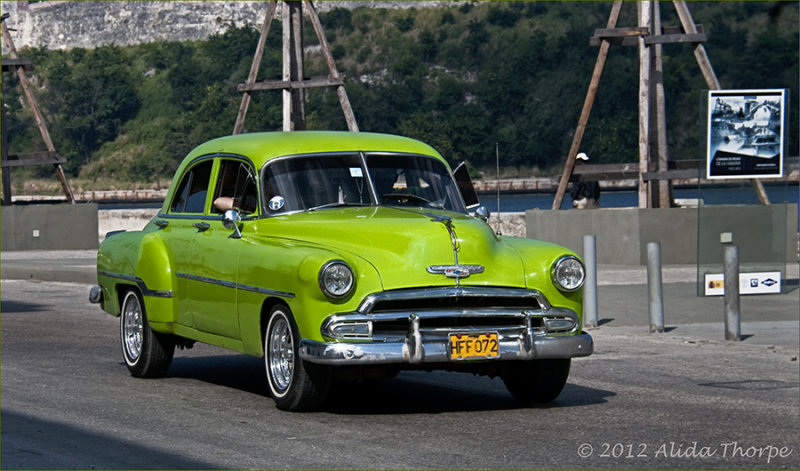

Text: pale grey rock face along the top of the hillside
xmin=0 ymin=0 xmax=455 ymax=53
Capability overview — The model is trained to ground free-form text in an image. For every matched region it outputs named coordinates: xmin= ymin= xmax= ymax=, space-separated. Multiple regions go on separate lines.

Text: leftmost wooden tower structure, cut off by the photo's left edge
xmin=0 ymin=13 xmax=75 ymax=205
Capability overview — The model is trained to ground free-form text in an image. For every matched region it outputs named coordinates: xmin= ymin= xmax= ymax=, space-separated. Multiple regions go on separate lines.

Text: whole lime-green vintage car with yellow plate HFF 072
xmin=90 ymin=131 xmax=593 ymax=410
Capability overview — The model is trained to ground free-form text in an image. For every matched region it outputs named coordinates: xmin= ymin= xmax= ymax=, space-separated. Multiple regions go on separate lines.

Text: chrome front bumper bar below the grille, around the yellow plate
xmin=300 ymin=334 xmax=594 ymax=366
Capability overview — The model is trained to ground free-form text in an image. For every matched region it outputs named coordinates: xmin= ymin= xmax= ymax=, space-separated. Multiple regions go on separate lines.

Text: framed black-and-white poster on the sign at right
xmin=706 ymin=89 xmax=786 ymax=180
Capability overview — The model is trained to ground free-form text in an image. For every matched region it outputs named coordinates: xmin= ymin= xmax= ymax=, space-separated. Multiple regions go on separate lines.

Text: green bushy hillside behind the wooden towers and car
xmin=3 ymin=1 xmax=800 ymax=194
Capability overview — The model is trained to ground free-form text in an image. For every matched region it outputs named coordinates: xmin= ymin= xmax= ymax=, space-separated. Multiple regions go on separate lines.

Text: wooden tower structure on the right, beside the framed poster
xmin=552 ymin=0 xmax=769 ymax=209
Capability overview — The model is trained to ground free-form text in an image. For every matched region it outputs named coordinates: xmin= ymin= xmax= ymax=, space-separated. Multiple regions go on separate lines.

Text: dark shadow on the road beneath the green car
xmin=166 ymin=355 xmax=615 ymax=415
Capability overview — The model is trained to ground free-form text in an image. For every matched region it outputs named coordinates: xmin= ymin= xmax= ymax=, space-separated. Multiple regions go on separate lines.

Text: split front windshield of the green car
xmin=263 ymin=154 xmax=465 ymax=214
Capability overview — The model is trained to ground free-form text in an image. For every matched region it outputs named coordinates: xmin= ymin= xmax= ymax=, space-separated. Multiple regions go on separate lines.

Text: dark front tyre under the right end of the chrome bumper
xmin=503 ymin=358 xmax=571 ymax=403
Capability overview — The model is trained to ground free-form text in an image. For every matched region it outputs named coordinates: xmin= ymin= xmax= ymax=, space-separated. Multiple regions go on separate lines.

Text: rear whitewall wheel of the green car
xmin=119 ymin=290 xmax=175 ymax=378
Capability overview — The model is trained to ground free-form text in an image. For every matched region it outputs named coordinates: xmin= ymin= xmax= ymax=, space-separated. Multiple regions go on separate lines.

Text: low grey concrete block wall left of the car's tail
xmin=0 ymin=204 xmax=97 ymax=250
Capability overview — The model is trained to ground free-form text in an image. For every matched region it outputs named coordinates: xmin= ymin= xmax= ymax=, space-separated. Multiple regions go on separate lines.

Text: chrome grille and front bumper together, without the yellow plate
xmin=299 ymin=287 xmax=594 ymax=365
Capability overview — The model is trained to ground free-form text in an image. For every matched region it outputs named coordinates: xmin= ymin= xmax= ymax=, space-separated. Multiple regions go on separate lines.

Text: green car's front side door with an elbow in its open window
xmin=189 ymin=157 xmax=258 ymax=340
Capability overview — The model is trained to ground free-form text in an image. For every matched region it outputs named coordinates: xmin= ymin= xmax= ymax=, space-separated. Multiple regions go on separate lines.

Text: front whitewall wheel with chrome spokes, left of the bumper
xmin=264 ymin=306 xmax=331 ymax=411
